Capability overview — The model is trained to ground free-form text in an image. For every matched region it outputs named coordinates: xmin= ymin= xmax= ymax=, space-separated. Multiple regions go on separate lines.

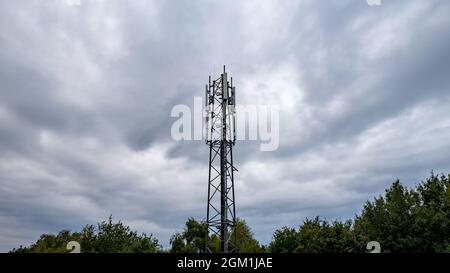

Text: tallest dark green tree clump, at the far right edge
xmin=354 ymin=173 xmax=450 ymax=252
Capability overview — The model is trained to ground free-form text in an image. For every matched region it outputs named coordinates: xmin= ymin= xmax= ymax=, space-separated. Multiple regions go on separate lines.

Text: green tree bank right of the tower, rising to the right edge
xmin=268 ymin=173 xmax=450 ymax=253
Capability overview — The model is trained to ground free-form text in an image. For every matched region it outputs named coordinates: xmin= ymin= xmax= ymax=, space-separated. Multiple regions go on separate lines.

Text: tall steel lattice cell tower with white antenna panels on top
xmin=205 ymin=66 xmax=237 ymax=253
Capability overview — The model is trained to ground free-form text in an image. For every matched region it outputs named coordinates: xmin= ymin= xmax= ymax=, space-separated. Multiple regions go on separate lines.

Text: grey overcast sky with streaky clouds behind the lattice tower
xmin=0 ymin=0 xmax=450 ymax=251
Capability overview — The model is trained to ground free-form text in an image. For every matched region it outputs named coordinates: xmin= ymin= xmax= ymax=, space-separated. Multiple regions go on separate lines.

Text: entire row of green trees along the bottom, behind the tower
xmin=11 ymin=173 xmax=450 ymax=253
